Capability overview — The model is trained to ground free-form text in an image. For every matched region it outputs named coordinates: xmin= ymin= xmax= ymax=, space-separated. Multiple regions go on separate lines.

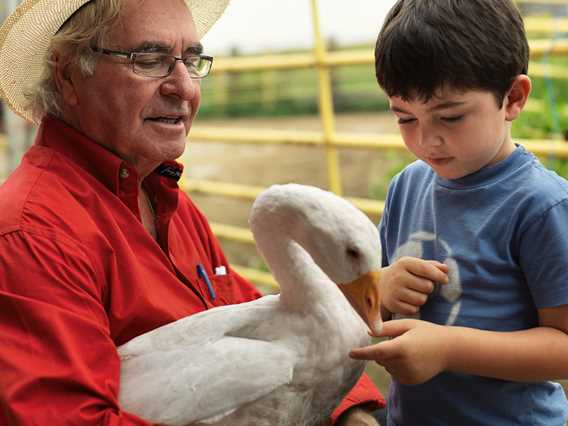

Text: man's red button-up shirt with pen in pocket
xmin=0 ymin=117 xmax=384 ymax=425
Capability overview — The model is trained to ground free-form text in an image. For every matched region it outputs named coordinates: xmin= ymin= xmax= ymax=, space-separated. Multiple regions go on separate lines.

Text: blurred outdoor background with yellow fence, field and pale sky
xmin=0 ymin=0 xmax=568 ymax=400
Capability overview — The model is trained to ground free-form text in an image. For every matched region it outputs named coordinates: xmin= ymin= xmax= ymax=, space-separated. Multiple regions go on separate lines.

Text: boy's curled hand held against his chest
xmin=381 ymin=257 xmax=448 ymax=319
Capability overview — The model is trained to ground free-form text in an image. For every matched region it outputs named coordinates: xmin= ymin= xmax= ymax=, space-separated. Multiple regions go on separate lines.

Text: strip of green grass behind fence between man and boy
xmin=199 ymin=57 xmax=388 ymax=118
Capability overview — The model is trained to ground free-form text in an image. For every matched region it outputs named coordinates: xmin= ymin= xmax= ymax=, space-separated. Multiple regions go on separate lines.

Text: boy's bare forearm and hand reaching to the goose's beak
xmin=351 ymin=305 xmax=568 ymax=384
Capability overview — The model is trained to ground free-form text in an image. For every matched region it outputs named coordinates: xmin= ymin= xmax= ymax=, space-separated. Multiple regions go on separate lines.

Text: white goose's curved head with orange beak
xmin=251 ymin=184 xmax=381 ymax=334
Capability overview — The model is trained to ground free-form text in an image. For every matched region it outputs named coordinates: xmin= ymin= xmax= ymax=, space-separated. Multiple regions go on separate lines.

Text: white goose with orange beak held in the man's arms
xmin=119 ymin=184 xmax=380 ymax=426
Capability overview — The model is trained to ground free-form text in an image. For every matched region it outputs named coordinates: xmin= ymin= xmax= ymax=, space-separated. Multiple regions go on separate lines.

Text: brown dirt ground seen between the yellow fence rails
xmin=184 ymin=113 xmax=397 ymax=266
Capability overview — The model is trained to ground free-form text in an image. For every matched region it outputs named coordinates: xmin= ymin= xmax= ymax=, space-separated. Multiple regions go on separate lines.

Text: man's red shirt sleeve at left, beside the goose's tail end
xmin=0 ymin=232 xmax=149 ymax=426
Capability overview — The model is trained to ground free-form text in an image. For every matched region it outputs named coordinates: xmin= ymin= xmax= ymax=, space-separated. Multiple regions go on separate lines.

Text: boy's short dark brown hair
xmin=375 ymin=0 xmax=529 ymax=108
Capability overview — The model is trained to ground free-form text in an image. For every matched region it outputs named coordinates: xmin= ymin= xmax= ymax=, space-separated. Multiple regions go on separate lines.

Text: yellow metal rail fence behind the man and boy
xmin=182 ymin=0 xmax=568 ymax=288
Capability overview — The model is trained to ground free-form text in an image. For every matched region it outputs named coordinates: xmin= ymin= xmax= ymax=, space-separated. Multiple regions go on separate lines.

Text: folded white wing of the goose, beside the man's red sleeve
xmin=119 ymin=296 xmax=296 ymax=426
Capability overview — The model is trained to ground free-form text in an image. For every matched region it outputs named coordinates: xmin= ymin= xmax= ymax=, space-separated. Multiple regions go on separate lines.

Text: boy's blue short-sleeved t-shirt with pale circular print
xmin=379 ymin=146 xmax=568 ymax=426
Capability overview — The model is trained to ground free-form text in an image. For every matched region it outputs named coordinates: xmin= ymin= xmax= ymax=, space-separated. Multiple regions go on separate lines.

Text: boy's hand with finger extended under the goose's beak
xmin=349 ymin=319 xmax=451 ymax=385
